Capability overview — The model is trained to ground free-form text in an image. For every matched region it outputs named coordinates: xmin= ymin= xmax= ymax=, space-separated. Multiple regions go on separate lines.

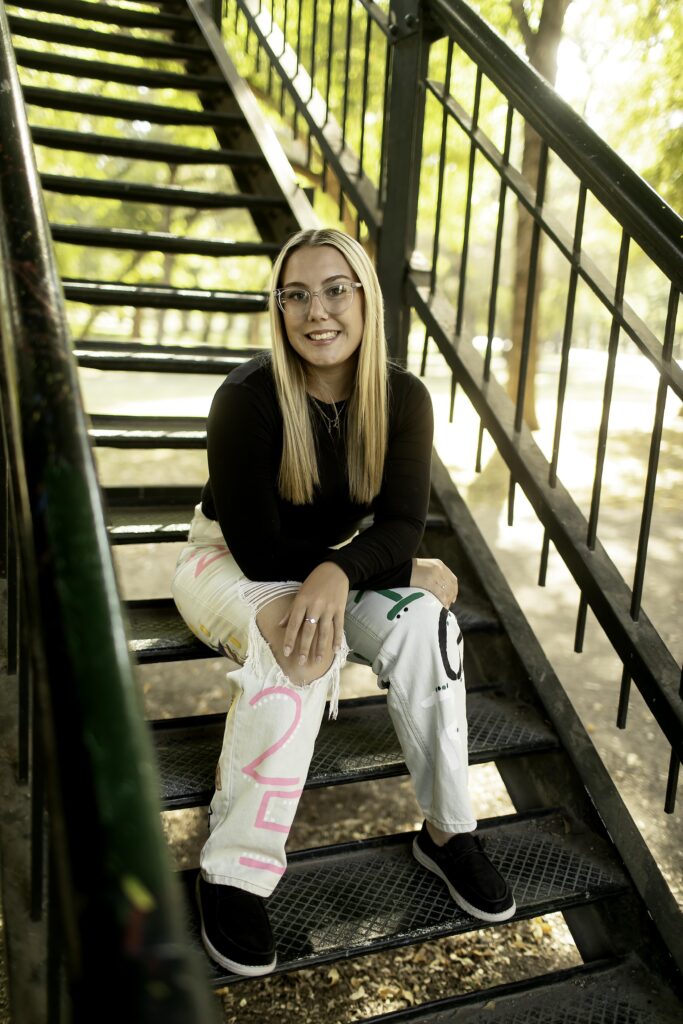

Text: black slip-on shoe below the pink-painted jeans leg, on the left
xmin=197 ymin=874 xmax=278 ymax=978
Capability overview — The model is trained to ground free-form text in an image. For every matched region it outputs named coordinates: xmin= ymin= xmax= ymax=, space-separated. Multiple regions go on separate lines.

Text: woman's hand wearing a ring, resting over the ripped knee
xmin=280 ymin=562 xmax=348 ymax=665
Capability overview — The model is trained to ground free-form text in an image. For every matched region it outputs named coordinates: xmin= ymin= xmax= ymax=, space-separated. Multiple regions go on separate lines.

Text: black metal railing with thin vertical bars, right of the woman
xmin=223 ymin=0 xmax=683 ymax=811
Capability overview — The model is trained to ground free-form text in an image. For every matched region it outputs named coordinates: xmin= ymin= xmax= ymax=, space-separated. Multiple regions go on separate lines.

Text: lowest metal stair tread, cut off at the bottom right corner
xmin=366 ymin=957 xmax=681 ymax=1024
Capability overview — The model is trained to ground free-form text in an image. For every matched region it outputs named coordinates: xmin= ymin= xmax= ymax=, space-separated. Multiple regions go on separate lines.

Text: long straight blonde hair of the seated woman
xmin=269 ymin=228 xmax=388 ymax=505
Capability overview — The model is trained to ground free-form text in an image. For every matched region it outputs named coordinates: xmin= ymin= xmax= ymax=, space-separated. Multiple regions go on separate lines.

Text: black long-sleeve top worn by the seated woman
xmin=202 ymin=356 xmax=433 ymax=590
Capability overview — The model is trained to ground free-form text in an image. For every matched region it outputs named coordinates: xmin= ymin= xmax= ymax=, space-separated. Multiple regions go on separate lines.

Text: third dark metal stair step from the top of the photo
xmin=14 ymin=46 xmax=227 ymax=92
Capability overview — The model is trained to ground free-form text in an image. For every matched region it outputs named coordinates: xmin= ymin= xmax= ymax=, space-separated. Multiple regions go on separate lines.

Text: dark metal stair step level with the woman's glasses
xmin=62 ymin=278 xmax=267 ymax=313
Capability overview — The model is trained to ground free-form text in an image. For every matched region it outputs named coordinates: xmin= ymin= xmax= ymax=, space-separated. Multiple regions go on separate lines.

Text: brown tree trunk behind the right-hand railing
xmin=508 ymin=0 xmax=571 ymax=430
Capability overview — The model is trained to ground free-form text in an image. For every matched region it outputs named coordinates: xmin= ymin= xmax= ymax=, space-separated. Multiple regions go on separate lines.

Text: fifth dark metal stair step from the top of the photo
xmin=31 ymin=127 xmax=265 ymax=167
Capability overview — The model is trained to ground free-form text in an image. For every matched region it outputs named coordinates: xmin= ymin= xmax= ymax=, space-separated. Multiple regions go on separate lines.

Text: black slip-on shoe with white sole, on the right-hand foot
xmin=413 ymin=822 xmax=516 ymax=922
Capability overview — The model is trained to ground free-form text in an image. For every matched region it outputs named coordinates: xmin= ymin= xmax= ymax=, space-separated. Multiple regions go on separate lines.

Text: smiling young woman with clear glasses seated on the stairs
xmin=173 ymin=230 xmax=515 ymax=975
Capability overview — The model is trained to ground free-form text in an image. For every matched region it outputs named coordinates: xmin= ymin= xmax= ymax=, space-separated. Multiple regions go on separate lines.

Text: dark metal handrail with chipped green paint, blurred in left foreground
xmin=0 ymin=8 xmax=219 ymax=1022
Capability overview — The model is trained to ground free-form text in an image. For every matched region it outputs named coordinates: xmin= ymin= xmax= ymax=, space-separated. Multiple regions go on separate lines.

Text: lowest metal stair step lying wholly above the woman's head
xmin=41 ymin=174 xmax=288 ymax=210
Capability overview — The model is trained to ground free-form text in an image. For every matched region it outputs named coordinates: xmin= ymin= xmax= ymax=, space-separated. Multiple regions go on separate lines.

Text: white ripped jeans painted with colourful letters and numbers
xmin=172 ymin=506 xmax=476 ymax=896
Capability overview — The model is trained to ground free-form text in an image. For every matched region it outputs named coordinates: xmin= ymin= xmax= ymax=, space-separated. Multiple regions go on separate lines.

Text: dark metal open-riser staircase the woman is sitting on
xmin=0 ymin=0 xmax=680 ymax=1024
